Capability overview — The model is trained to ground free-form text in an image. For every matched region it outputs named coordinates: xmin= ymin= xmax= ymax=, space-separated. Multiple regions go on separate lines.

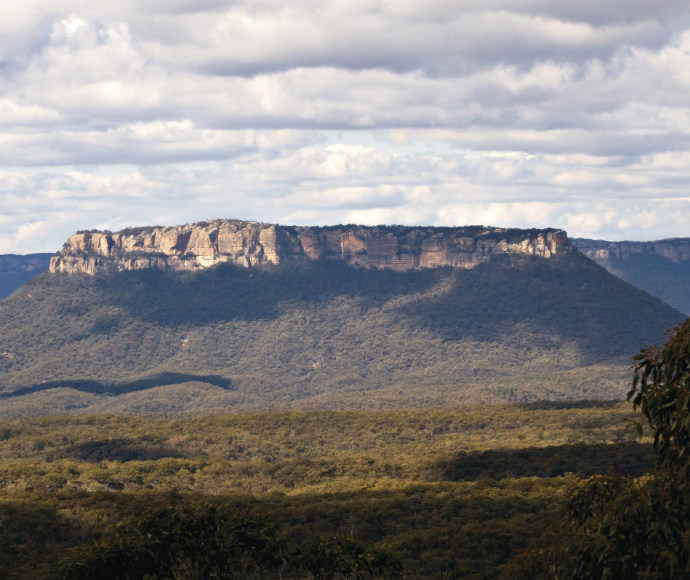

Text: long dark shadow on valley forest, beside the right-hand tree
xmin=429 ymin=441 xmax=656 ymax=481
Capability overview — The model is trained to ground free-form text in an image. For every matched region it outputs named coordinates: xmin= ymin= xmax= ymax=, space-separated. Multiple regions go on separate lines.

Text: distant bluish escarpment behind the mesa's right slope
xmin=571 ymin=238 xmax=690 ymax=315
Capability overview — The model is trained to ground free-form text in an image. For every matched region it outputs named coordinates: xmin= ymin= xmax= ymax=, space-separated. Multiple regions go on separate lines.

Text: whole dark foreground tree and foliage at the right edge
xmin=539 ymin=319 xmax=690 ymax=580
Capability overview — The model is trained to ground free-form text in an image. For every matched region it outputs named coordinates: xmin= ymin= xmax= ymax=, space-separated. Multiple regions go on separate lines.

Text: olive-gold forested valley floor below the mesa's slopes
xmin=0 ymin=402 xmax=656 ymax=580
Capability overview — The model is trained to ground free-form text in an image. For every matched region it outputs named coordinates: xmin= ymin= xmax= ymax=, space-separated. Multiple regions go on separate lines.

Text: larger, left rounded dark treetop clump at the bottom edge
xmin=63 ymin=503 xmax=288 ymax=580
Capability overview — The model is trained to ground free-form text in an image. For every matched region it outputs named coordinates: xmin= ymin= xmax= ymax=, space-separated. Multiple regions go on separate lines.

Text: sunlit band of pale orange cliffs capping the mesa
xmin=50 ymin=220 xmax=574 ymax=274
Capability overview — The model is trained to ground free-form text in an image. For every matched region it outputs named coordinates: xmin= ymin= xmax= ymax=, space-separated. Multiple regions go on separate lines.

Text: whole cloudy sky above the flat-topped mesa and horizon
xmin=0 ymin=0 xmax=690 ymax=254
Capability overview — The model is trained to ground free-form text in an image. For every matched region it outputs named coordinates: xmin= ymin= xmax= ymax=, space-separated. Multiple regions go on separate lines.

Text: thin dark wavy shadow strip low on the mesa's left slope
xmin=0 ymin=372 xmax=231 ymax=399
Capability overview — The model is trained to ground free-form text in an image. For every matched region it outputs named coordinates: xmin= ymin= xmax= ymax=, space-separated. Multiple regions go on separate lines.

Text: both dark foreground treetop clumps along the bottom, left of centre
xmin=57 ymin=494 xmax=402 ymax=580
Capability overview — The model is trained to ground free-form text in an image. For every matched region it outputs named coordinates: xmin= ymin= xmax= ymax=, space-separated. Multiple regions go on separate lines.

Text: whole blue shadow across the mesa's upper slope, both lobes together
xmin=105 ymin=253 xmax=679 ymax=363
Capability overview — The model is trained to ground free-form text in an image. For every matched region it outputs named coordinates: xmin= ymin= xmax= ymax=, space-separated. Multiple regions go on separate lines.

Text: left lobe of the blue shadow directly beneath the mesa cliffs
xmin=95 ymin=260 xmax=438 ymax=326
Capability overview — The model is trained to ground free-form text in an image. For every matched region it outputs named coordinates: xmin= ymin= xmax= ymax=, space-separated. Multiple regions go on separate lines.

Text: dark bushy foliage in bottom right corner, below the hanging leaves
xmin=535 ymin=471 xmax=690 ymax=580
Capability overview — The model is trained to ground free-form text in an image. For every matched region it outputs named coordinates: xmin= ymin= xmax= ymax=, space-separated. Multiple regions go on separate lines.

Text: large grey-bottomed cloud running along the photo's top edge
xmin=114 ymin=1 xmax=686 ymax=76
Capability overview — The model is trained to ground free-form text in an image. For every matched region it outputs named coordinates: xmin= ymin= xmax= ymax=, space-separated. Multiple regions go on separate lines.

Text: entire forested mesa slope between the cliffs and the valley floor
xmin=0 ymin=252 xmax=683 ymax=417
